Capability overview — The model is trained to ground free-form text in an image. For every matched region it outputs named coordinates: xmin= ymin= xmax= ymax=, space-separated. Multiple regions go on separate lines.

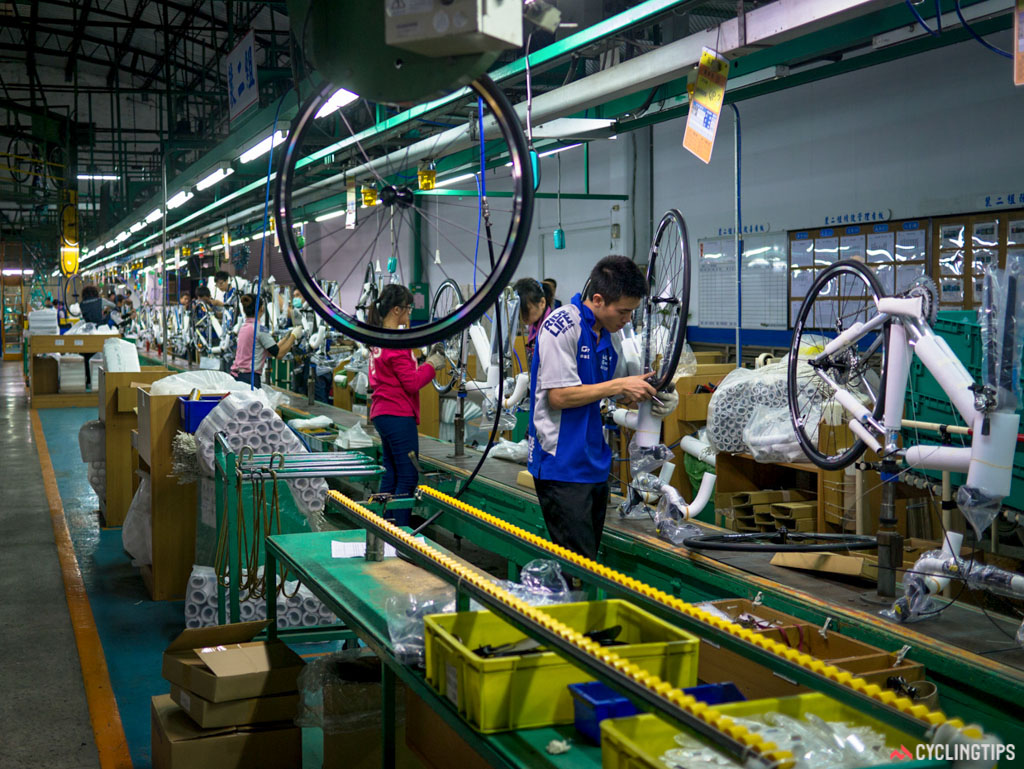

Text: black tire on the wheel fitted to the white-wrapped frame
xmin=786 ymin=259 xmax=889 ymax=470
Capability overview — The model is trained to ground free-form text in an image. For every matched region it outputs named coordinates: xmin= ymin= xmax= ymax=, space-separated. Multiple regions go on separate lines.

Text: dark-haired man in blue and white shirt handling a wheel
xmin=527 ymin=256 xmax=654 ymax=559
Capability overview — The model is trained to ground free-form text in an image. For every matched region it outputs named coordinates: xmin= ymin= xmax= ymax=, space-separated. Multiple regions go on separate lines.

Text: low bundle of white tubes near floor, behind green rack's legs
xmin=185 ymin=565 xmax=338 ymax=628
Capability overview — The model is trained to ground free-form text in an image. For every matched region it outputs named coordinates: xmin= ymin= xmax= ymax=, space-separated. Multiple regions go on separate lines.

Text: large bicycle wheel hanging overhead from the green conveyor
xmin=275 ymin=76 xmax=534 ymax=348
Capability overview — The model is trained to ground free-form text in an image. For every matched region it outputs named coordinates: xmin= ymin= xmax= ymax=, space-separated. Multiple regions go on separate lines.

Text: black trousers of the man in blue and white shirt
xmin=535 ymin=479 xmax=609 ymax=560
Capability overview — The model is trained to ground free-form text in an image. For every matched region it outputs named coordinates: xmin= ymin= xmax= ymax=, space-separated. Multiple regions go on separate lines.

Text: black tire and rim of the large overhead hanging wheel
xmin=274 ymin=75 xmax=534 ymax=349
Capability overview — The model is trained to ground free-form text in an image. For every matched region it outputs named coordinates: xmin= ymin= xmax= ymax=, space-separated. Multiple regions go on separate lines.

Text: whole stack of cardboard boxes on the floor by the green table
xmin=151 ymin=621 xmax=303 ymax=769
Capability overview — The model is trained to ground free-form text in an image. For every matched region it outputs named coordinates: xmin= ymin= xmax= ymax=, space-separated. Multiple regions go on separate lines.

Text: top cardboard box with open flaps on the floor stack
xmin=163 ymin=620 xmax=304 ymax=702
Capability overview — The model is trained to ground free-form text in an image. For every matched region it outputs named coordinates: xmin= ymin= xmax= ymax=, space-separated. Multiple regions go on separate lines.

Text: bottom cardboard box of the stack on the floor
xmin=150 ymin=694 xmax=302 ymax=769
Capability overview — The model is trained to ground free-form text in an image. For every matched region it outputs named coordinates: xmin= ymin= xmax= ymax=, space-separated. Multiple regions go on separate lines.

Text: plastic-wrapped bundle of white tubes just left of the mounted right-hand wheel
xmin=708 ymin=364 xmax=796 ymax=454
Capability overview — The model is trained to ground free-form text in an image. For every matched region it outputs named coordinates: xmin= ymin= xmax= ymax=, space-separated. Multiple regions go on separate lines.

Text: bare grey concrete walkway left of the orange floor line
xmin=0 ymin=361 xmax=99 ymax=769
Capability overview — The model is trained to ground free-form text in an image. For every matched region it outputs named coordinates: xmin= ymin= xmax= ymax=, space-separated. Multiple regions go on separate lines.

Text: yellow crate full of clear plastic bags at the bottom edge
xmin=601 ymin=692 xmax=921 ymax=769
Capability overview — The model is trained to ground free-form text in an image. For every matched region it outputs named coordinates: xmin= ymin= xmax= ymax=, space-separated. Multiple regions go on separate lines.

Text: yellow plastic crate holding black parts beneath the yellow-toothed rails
xmin=424 ymin=600 xmax=699 ymax=733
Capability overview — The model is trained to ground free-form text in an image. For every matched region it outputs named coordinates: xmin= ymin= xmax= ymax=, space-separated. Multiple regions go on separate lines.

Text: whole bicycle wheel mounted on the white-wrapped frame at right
xmin=787 ymin=259 xmax=889 ymax=470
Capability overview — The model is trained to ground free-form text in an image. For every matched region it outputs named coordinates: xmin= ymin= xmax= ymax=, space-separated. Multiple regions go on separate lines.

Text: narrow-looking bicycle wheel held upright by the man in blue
xmin=641 ymin=208 xmax=690 ymax=390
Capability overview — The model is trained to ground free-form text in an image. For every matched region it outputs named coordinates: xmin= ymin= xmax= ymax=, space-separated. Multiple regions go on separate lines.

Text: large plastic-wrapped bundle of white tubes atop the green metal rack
xmin=192 ymin=397 xmax=327 ymax=531
